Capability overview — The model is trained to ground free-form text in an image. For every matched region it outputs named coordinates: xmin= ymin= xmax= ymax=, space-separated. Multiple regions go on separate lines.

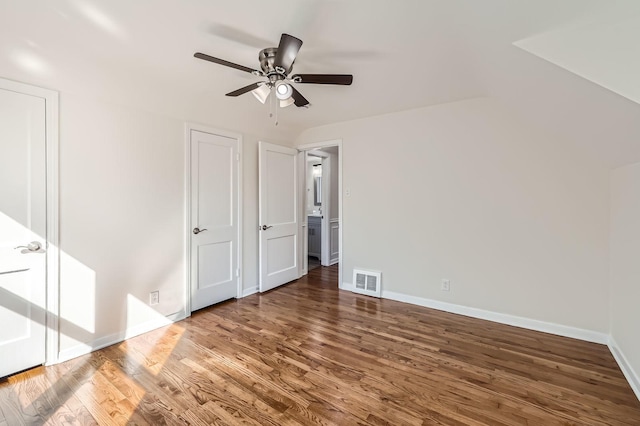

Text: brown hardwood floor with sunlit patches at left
xmin=0 ymin=267 xmax=640 ymax=426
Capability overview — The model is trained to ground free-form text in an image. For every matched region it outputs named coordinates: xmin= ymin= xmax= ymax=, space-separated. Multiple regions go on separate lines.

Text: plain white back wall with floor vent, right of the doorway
xmin=296 ymin=98 xmax=609 ymax=333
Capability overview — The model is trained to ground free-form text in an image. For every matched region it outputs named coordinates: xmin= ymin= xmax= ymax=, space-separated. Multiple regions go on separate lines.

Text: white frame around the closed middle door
xmin=184 ymin=123 xmax=244 ymax=317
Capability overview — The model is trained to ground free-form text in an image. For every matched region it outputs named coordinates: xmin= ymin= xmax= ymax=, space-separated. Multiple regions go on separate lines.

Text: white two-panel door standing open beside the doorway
xmin=258 ymin=142 xmax=298 ymax=292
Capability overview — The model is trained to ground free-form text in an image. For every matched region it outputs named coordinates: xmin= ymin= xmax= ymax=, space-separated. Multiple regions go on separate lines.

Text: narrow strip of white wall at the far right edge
xmin=611 ymin=163 xmax=640 ymax=397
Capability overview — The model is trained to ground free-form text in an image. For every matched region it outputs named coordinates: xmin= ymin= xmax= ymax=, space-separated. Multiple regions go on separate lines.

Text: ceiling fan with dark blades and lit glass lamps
xmin=193 ymin=34 xmax=353 ymax=107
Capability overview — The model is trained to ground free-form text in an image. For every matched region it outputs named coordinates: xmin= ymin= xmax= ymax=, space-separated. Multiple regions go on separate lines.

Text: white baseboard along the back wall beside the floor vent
xmin=340 ymin=283 xmax=609 ymax=345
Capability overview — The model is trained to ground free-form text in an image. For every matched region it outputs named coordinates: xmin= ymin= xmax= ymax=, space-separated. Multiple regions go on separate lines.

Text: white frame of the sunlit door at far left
xmin=0 ymin=78 xmax=60 ymax=365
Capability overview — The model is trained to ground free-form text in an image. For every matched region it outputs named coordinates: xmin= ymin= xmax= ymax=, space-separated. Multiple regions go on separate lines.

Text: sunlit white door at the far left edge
xmin=0 ymin=85 xmax=46 ymax=377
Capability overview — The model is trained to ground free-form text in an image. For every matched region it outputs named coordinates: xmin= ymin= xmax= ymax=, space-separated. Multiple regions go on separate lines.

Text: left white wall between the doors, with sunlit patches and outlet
xmin=55 ymin=92 xmax=282 ymax=358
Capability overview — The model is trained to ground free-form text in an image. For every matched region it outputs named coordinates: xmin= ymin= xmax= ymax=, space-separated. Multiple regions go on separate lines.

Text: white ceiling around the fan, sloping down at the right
xmin=0 ymin=0 xmax=640 ymax=167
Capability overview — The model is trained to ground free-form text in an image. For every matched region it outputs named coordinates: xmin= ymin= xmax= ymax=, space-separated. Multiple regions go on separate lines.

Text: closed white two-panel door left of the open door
xmin=190 ymin=129 xmax=239 ymax=311
